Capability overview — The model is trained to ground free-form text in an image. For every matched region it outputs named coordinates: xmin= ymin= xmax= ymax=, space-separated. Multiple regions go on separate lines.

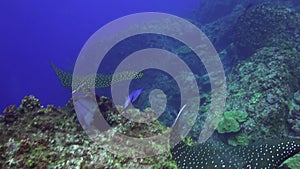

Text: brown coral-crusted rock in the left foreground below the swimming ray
xmin=0 ymin=96 xmax=176 ymax=168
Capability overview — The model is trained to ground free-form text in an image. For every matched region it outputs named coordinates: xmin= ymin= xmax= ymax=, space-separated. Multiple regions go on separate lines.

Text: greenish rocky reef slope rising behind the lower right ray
xmin=190 ymin=1 xmax=300 ymax=168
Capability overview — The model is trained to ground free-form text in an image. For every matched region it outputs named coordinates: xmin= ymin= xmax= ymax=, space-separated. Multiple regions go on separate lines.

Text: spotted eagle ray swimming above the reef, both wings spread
xmin=50 ymin=63 xmax=144 ymax=89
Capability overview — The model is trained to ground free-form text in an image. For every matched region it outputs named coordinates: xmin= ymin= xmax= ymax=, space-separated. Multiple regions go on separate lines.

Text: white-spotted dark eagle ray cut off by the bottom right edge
xmin=171 ymin=139 xmax=300 ymax=169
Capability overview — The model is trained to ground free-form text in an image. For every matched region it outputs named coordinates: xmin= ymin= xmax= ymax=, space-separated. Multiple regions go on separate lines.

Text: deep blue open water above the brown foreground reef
xmin=0 ymin=0 xmax=199 ymax=113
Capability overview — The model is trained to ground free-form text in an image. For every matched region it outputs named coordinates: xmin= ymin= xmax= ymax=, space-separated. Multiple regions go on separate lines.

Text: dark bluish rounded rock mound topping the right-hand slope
xmin=234 ymin=4 xmax=300 ymax=58
